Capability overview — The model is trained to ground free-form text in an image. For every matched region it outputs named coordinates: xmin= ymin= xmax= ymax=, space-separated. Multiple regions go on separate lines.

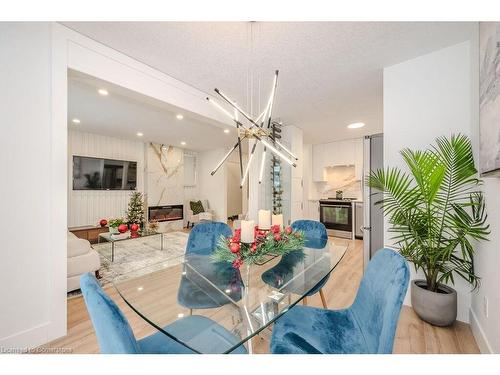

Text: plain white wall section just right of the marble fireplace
xmin=197 ymin=148 xmax=227 ymax=223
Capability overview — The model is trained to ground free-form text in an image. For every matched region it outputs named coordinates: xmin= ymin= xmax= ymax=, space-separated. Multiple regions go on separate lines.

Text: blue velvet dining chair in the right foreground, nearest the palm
xmin=271 ymin=249 xmax=410 ymax=354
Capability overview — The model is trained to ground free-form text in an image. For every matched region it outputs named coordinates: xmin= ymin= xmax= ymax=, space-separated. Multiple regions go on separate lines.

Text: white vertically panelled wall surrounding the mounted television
xmin=68 ymin=130 xmax=145 ymax=227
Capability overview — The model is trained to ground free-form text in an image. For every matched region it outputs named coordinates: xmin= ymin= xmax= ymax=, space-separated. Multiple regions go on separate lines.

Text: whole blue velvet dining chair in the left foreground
xmin=80 ymin=273 xmax=246 ymax=354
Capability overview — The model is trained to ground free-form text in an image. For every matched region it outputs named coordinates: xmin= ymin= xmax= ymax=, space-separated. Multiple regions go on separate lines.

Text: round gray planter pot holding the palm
xmin=411 ymin=280 xmax=457 ymax=327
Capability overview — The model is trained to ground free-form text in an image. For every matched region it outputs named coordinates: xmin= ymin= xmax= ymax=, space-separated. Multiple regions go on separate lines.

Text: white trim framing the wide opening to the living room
xmin=43 ymin=23 xmax=233 ymax=346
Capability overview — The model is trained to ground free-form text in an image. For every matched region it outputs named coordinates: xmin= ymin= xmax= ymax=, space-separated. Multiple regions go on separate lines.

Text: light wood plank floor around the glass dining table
xmin=41 ymin=241 xmax=479 ymax=354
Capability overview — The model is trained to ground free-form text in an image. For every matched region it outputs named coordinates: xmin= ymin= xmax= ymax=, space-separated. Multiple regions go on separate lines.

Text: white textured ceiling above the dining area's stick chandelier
xmin=65 ymin=22 xmax=474 ymax=143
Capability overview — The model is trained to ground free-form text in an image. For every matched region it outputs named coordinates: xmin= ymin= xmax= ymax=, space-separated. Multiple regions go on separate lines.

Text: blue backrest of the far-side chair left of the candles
xmin=186 ymin=221 xmax=233 ymax=255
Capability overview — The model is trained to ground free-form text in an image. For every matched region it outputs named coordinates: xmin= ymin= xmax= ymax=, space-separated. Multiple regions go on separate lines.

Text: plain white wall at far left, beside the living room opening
xmin=0 ymin=23 xmax=66 ymax=348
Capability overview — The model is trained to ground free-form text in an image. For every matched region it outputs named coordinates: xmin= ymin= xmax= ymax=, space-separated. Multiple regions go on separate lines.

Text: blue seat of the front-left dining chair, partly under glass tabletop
xmin=138 ymin=315 xmax=247 ymax=354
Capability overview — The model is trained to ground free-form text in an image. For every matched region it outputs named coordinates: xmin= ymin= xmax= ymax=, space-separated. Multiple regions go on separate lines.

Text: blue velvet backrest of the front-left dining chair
xmin=80 ymin=273 xmax=140 ymax=354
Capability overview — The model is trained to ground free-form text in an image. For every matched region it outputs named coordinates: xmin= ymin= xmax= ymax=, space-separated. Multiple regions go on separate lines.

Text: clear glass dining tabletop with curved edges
xmin=113 ymin=238 xmax=349 ymax=353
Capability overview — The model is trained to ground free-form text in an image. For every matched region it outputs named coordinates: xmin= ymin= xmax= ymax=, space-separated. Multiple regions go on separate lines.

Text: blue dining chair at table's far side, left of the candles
xmin=177 ymin=222 xmax=243 ymax=314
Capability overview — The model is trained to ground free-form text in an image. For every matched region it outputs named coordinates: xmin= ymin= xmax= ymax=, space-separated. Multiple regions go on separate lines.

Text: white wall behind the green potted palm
xmin=384 ymin=42 xmax=477 ymax=322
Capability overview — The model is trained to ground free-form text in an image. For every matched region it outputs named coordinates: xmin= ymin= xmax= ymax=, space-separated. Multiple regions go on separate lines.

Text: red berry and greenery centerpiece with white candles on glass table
xmin=212 ymin=210 xmax=305 ymax=268
